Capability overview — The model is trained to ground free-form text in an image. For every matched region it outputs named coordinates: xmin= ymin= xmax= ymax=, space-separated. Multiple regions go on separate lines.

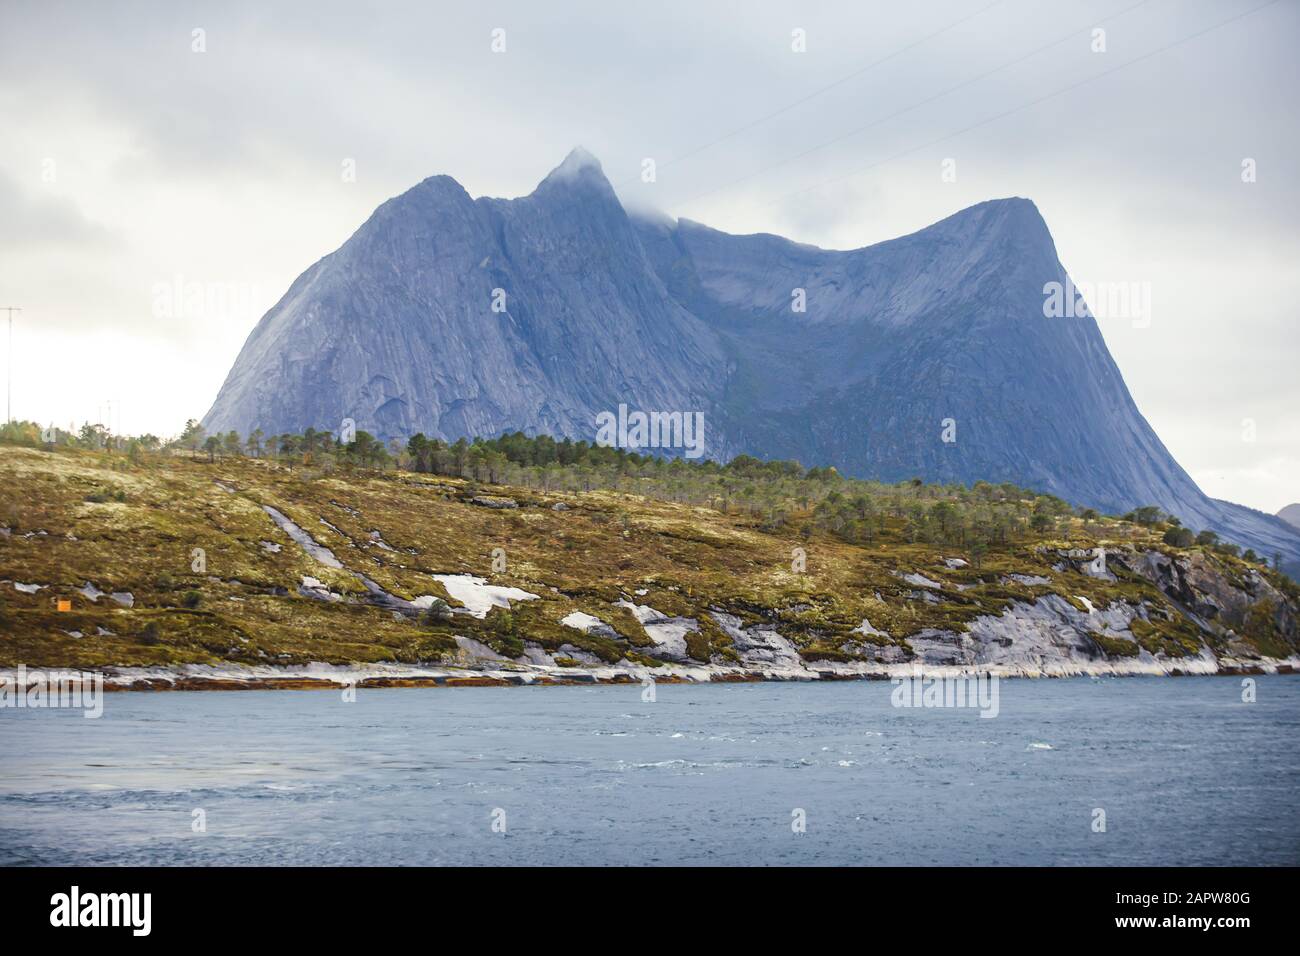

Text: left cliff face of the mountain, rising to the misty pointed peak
xmin=204 ymin=151 xmax=725 ymax=454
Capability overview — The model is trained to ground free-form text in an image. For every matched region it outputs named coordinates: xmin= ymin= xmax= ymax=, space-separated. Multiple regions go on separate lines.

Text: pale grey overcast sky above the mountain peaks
xmin=0 ymin=0 xmax=1300 ymax=511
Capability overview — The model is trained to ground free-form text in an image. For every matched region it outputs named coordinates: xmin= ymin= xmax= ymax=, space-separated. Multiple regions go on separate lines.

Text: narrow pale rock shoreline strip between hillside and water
xmin=0 ymin=657 xmax=1300 ymax=692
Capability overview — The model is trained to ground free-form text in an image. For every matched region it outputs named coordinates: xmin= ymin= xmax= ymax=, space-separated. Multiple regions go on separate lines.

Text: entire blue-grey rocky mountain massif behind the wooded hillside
xmin=203 ymin=150 xmax=1300 ymax=566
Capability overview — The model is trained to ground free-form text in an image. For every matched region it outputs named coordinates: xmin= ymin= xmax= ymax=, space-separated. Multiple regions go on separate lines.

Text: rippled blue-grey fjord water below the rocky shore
xmin=0 ymin=676 xmax=1300 ymax=865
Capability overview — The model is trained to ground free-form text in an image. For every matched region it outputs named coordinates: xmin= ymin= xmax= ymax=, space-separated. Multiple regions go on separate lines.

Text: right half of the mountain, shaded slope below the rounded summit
xmin=629 ymin=199 xmax=1205 ymax=512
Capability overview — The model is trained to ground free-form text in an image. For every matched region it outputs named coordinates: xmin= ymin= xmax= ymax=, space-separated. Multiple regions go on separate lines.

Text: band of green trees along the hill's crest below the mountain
xmin=0 ymin=419 xmax=1278 ymax=564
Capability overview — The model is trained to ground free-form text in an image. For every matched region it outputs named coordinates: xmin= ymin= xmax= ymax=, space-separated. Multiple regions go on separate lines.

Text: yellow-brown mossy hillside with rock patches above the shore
xmin=0 ymin=445 xmax=1295 ymax=666
